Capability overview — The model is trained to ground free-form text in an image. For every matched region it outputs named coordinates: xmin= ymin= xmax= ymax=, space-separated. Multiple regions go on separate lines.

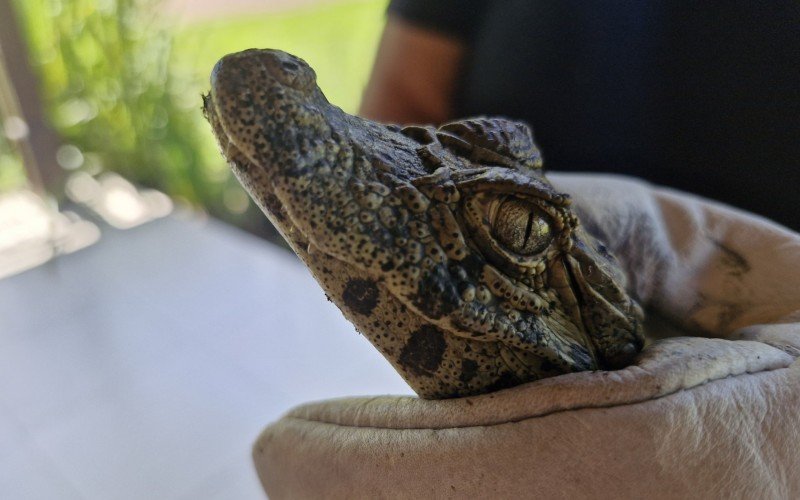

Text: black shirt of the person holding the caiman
xmin=389 ymin=0 xmax=800 ymax=230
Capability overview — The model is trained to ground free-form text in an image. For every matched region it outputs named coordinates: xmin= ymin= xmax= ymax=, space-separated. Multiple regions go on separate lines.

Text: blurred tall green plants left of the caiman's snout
xmin=17 ymin=0 xmax=215 ymax=205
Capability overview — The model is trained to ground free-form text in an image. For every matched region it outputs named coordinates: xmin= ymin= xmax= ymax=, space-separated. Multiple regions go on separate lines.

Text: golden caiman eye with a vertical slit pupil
xmin=489 ymin=198 xmax=553 ymax=256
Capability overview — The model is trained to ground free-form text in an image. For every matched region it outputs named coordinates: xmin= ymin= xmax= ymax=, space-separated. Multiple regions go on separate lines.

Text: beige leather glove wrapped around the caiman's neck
xmin=254 ymin=175 xmax=800 ymax=498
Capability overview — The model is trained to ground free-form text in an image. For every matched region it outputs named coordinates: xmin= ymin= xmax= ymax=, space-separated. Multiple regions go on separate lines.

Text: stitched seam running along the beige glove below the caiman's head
xmin=281 ymin=365 xmax=791 ymax=431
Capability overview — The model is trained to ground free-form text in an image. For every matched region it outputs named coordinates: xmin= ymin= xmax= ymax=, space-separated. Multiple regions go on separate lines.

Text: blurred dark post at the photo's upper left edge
xmin=0 ymin=0 xmax=64 ymax=197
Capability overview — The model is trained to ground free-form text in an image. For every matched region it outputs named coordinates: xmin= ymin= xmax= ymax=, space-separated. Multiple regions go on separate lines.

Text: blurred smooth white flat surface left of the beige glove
xmin=0 ymin=215 xmax=412 ymax=499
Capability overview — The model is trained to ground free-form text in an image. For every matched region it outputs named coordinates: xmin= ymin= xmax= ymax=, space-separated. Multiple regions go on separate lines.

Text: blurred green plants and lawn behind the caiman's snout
xmin=10 ymin=0 xmax=386 ymax=218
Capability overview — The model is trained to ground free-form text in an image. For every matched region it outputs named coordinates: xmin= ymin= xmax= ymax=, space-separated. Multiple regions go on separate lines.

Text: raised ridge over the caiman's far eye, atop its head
xmin=436 ymin=117 xmax=542 ymax=169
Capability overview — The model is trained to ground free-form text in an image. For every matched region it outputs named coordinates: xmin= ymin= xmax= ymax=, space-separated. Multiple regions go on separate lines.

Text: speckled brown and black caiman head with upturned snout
xmin=204 ymin=50 xmax=643 ymax=398
